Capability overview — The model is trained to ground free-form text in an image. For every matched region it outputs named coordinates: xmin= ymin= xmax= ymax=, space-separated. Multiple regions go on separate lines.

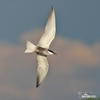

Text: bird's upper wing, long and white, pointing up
xmin=38 ymin=7 xmax=56 ymax=49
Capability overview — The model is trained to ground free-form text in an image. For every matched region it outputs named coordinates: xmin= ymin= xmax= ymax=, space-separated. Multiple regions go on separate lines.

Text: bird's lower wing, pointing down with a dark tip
xmin=36 ymin=54 xmax=49 ymax=87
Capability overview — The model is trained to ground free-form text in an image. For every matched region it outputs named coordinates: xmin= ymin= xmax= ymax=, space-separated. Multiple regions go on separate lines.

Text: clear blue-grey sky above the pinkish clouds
xmin=0 ymin=0 xmax=100 ymax=43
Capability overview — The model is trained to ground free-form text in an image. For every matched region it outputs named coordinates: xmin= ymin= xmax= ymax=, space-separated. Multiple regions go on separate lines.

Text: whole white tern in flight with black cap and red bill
xmin=25 ymin=7 xmax=56 ymax=87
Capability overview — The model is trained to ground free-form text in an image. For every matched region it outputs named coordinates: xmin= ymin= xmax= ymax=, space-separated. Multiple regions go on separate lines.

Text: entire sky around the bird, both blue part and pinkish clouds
xmin=0 ymin=0 xmax=100 ymax=100
